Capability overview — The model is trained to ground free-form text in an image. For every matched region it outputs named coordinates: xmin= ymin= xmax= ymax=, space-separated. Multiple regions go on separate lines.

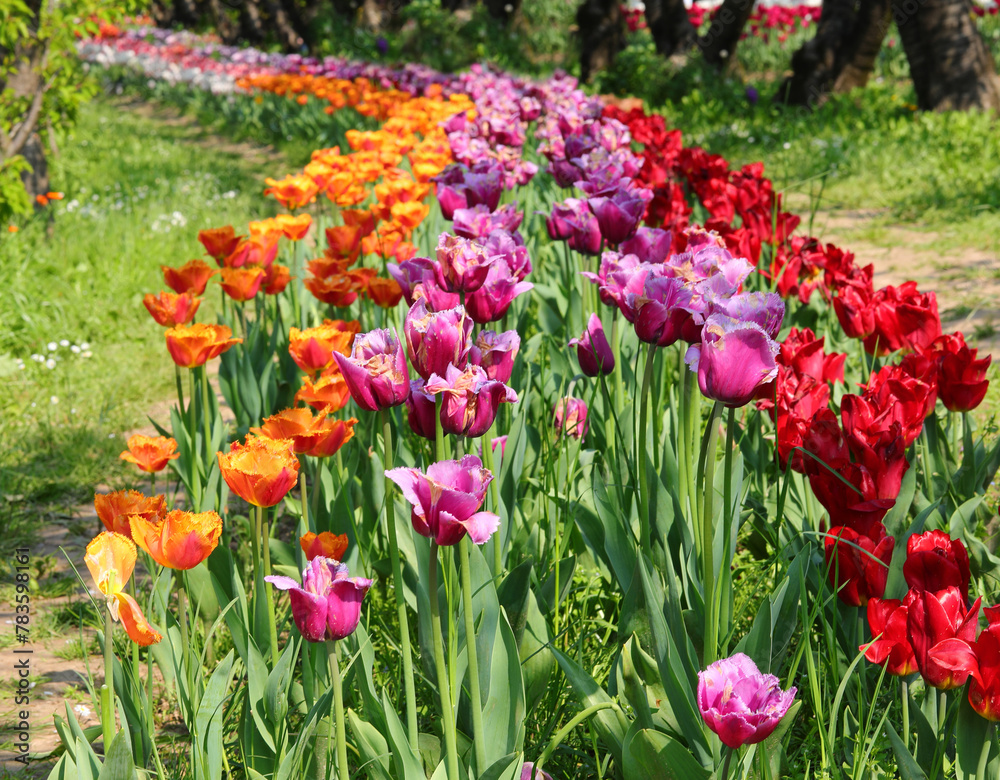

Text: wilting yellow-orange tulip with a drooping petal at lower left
xmin=84 ymin=531 xmax=163 ymax=647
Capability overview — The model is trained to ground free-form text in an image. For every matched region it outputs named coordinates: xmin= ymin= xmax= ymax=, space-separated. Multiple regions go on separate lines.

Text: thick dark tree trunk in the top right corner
xmin=892 ymin=0 xmax=1000 ymax=111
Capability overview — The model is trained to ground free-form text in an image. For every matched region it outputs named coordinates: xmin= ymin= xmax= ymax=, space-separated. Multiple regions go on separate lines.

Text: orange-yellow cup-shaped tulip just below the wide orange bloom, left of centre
xmin=218 ymin=436 xmax=299 ymax=506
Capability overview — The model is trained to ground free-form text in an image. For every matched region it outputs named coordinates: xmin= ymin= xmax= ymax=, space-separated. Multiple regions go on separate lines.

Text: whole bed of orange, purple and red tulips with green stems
xmin=60 ymin=25 xmax=1000 ymax=778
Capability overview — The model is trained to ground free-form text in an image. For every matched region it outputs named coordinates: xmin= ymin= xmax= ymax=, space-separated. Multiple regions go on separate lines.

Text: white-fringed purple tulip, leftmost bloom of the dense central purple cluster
xmin=333 ymin=328 xmax=410 ymax=412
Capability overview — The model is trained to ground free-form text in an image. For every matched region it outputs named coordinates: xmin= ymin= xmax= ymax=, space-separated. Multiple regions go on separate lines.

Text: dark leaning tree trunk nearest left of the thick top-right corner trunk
xmin=774 ymin=0 xmax=860 ymax=106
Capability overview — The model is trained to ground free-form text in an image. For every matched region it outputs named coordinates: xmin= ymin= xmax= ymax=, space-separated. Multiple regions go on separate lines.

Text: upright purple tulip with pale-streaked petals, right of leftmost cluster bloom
xmin=403 ymin=298 xmax=472 ymax=379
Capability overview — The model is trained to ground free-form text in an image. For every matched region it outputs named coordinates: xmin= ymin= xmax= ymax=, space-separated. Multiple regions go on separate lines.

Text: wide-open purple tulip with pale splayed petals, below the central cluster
xmin=385 ymin=455 xmax=500 ymax=547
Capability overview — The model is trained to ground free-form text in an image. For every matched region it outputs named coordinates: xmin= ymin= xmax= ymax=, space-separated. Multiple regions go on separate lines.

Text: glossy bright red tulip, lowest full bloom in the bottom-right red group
xmin=906 ymin=587 xmax=979 ymax=690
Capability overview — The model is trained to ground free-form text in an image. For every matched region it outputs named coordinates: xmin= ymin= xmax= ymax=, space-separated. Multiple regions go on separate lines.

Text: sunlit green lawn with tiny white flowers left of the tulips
xmin=0 ymin=94 xmax=283 ymax=540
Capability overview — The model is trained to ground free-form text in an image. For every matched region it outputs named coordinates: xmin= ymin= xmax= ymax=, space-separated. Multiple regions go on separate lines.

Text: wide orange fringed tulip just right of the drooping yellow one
xmin=129 ymin=509 xmax=222 ymax=570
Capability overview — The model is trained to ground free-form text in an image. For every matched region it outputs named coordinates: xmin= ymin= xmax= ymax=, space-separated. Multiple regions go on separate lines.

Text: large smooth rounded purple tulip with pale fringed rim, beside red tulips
xmin=684 ymin=314 xmax=779 ymax=407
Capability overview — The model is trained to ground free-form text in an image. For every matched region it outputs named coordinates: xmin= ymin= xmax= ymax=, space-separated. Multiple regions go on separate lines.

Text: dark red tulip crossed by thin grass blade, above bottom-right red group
xmin=823 ymin=524 xmax=896 ymax=607
